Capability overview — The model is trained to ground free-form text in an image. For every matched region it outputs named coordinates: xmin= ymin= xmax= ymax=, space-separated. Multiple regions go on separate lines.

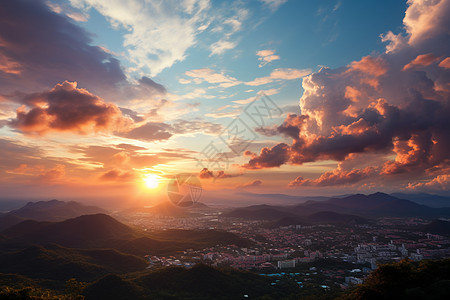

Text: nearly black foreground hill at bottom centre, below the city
xmin=85 ymin=265 xmax=301 ymax=300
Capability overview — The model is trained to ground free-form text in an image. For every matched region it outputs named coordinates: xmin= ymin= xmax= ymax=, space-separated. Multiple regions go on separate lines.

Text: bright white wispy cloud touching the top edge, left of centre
xmin=70 ymin=0 xmax=210 ymax=76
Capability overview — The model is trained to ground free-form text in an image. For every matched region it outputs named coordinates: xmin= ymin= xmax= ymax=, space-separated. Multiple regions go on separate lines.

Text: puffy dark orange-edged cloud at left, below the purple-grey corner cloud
xmin=9 ymin=81 xmax=129 ymax=135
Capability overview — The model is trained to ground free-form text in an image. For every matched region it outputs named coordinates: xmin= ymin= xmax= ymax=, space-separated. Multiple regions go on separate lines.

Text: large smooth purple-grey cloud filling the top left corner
xmin=0 ymin=0 xmax=125 ymax=93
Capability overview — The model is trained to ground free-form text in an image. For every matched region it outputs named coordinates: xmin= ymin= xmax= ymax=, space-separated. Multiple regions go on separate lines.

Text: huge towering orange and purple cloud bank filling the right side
xmin=242 ymin=0 xmax=450 ymax=190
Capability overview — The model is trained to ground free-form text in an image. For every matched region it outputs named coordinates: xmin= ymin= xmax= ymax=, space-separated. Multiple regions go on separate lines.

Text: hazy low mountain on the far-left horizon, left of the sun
xmin=9 ymin=200 xmax=106 ymax=221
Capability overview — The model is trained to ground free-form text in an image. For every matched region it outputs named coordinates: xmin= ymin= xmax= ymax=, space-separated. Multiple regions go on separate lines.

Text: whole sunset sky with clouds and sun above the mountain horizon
xmin=0 ymin=0 xmax=450 ymax=204
